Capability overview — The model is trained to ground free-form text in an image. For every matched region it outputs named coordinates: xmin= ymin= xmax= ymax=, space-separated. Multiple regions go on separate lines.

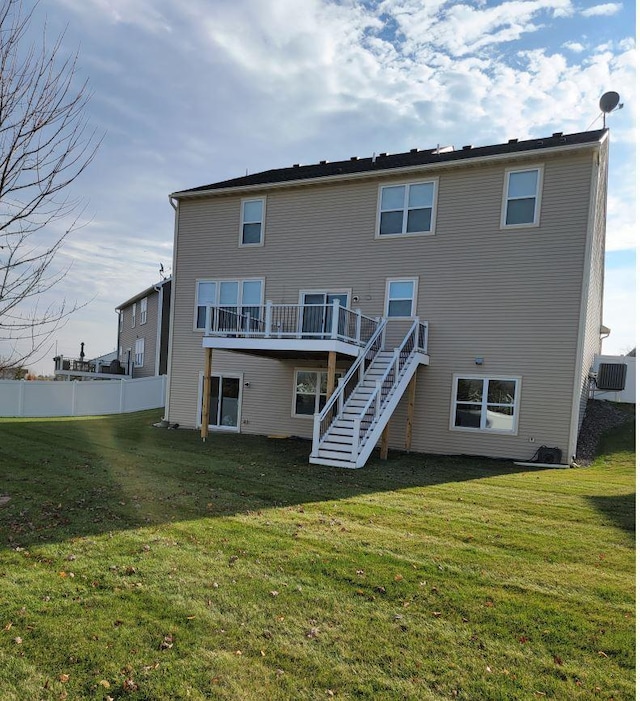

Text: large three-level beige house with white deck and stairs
xmin=164 ymin=130 xmax=608 ymax=467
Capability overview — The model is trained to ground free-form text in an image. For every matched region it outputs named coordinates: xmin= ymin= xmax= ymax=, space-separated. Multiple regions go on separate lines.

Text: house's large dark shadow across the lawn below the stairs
xmin=0 ymin=412 xmax=535 ymax=547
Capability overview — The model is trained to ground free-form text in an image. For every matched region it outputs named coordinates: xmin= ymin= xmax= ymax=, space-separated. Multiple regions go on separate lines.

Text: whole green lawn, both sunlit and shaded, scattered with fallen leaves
xmin=0 ymin=411 xmax=635 ymax=701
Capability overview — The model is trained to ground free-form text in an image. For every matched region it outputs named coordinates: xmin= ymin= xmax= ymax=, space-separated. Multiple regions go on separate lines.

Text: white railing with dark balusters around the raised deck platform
xmin=205 ymin=299 xmax=378 ymax=346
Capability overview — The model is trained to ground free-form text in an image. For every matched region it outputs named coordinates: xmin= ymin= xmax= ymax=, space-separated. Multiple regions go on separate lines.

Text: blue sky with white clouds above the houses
xmin=5 ymin=0 xmax=636 ymax=372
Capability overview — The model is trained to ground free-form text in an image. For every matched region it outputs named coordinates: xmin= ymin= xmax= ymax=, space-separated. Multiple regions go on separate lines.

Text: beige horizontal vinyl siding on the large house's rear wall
xmin=169 ymin=146 xmax=592 ymax=458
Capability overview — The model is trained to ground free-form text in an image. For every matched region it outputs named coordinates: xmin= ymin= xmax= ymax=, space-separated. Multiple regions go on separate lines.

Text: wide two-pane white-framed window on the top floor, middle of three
xmin=376 ymin=180 xmax=438 ymax=238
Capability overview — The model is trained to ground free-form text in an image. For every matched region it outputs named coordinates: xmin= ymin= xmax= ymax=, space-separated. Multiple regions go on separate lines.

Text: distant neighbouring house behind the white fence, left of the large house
xmin=116 ymin=278 xmax=171 ymax=378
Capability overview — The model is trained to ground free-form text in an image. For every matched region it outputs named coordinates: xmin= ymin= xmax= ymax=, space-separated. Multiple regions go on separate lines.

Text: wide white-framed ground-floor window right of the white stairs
xmin=451 ymin=374 xmax=521 ymax=434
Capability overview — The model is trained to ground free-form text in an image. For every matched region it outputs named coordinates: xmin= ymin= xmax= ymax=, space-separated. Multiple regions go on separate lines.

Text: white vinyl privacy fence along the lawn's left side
xmin=0 ymin=375 xmax=166 ymax=417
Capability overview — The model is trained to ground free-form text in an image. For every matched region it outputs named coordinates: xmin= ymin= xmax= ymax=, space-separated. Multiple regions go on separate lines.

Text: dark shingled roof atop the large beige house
xmin=173 ymin=129 xmax=607 ymax=196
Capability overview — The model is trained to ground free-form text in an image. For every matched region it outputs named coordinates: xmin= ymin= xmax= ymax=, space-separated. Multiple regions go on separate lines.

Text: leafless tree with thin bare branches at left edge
xmin=0 ymin=0 xmax=99 ymax=369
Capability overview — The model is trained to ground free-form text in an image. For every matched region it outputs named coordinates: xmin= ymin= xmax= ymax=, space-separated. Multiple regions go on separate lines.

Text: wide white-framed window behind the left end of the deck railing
xmin=194 ymin=278 xmax=264 ymax=330
